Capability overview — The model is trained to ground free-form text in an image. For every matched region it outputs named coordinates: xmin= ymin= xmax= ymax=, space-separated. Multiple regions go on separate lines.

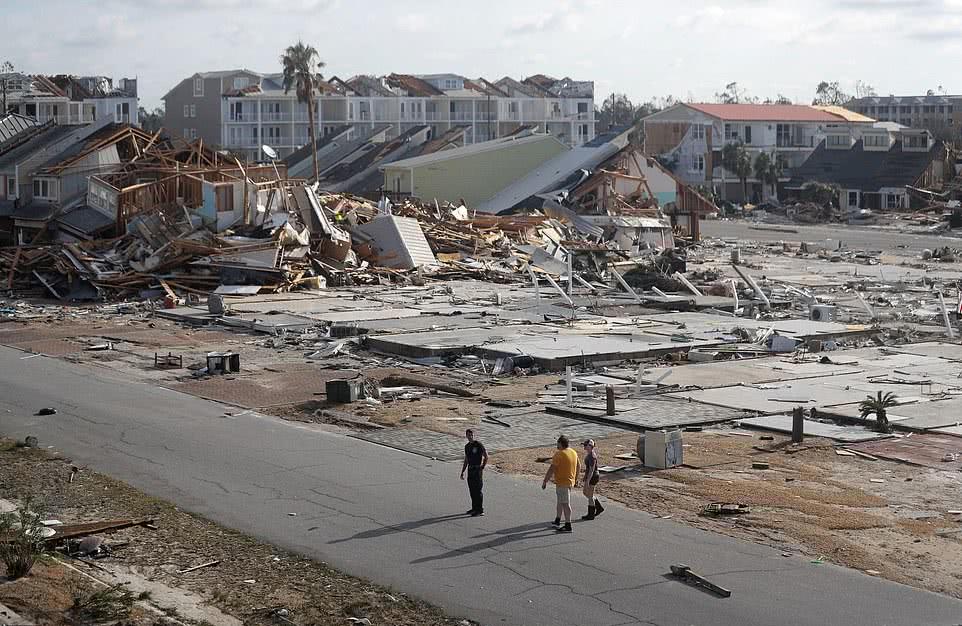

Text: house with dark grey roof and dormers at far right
xmin=785 ymin=129 xmax=954 ymax=211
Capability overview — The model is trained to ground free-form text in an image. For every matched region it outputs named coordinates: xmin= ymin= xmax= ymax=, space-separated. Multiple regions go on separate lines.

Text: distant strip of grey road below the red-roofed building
xmin=701 ymin=220 xmax=962 ymax=253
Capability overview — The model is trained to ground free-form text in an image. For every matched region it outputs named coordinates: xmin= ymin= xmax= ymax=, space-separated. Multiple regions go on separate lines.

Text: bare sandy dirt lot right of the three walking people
xmin=492 ymin=431 xmax=962 ymax=598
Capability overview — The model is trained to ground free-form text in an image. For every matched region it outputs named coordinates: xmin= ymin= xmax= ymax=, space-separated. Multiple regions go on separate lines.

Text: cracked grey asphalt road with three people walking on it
xmin=0 ymin=348 xmax=962 ymax=626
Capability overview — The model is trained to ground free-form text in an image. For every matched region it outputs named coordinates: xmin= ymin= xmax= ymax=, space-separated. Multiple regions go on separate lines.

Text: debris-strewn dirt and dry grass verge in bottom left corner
xmin=0 ymin=440 xmax=468 ymax=626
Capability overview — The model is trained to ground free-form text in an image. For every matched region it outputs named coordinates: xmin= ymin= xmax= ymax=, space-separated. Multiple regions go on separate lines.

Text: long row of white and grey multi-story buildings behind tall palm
xmin=164 ymin=70 xmax=595 ymax=160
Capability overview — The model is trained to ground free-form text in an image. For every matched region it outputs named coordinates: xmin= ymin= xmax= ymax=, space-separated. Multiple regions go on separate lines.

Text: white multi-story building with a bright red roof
xmin=644 ymin=103 xmax=875 ymax=200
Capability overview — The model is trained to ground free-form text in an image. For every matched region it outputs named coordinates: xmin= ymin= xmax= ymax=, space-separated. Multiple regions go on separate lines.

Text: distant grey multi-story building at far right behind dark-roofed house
xmin=845 ymin=95 xmax=962 ymax=141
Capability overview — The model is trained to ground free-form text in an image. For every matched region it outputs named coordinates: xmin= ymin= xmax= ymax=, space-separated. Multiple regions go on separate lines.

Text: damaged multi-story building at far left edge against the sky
xmin=0 ymin=72 xmax=139 ymax=126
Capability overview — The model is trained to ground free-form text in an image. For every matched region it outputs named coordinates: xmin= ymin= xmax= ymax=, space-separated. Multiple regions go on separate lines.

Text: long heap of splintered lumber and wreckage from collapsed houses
xmin=0 ymin=179 xmax=684 ymax=306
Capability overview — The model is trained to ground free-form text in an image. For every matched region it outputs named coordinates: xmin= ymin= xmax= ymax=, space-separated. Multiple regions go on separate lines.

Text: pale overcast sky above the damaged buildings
xmin=7 ymin=0 xmax=962 ymax=108
